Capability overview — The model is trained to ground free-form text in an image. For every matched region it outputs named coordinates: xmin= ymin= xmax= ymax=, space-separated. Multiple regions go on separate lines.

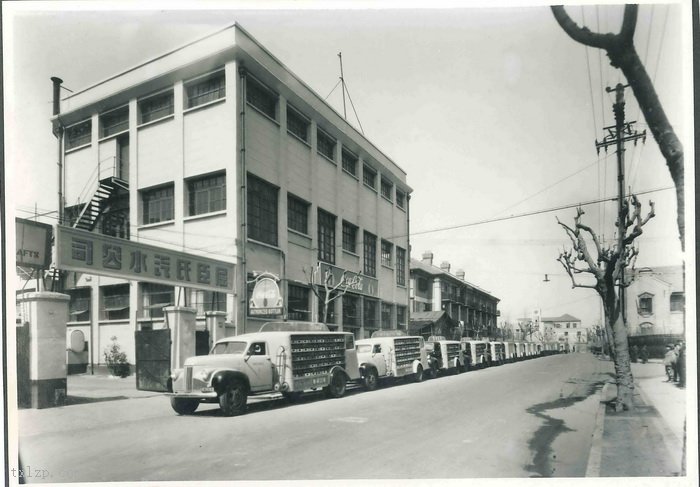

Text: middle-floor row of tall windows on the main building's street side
xmin=247 ymin=174 xmax=406 ymax=286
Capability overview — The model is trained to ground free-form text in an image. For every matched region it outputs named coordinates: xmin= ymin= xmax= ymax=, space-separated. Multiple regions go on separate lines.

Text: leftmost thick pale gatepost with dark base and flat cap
xmin=19 ymin=292 xmax=70 ymax=409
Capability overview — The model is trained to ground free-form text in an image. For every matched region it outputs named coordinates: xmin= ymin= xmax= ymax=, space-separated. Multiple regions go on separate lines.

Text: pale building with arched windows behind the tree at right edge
xmin=625 ymin=266 xmax=685 ymax=336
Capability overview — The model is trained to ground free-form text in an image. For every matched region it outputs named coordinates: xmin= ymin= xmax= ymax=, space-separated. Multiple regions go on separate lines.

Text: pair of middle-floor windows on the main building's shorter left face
xmin=140 ymin=173 xmax=226 ymax=225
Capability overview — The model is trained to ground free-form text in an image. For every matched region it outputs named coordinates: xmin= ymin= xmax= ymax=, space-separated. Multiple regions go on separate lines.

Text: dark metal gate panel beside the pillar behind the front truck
xmin=135 ymin=328 xmax=171 ymax=392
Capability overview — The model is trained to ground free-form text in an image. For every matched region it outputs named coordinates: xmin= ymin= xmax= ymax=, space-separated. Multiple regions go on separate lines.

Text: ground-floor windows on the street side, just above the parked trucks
xmin=288 ymin=284 xmax=406 ymax=329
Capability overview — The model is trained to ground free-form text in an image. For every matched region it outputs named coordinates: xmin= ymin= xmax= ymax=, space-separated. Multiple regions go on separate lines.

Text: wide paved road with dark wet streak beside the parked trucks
xmin=19 ymin=354 xmax=611 ymax=482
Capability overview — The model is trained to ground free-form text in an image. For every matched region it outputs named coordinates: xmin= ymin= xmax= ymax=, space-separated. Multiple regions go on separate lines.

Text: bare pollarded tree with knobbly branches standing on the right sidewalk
xmin=557 ymin=195 xmax=654 ymax=411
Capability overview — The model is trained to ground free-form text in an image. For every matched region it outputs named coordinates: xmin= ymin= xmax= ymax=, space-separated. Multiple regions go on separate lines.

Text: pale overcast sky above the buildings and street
xmin=3 ymin=2 xmax=693 ymax=325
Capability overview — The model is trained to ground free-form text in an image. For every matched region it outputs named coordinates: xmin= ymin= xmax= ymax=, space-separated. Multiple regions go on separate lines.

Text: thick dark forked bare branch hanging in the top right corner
xmin=552 ymin=5 xmax=685 ymax=249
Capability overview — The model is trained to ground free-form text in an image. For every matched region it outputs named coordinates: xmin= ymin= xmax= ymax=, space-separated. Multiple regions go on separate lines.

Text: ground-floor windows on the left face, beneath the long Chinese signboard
xmin=68 ymin=283 xmax=226 ymax=322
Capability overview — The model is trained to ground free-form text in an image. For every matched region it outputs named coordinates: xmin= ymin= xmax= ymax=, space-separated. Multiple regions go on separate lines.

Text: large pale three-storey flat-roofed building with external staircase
xmin=52 ymin=25 xmax=411 ymax=370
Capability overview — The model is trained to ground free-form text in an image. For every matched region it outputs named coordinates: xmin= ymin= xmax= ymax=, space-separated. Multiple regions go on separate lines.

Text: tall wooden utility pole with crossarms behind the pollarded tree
xmin=595 ymin=83 xmax=647 ymax=324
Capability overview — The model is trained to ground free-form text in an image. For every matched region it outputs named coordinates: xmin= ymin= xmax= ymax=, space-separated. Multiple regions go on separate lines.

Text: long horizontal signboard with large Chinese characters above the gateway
xmin=56 ymin=225 xmax=234 ymax=293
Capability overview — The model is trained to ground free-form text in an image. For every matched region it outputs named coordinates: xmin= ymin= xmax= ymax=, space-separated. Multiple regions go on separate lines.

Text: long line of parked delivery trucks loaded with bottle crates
xmin=169 ymin=322 xmax=557 ymax=416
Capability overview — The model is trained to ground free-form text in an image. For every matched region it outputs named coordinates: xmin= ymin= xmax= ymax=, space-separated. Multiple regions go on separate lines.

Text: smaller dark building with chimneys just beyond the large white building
xmin=410 ymin=252 xmax=500 ymax=337
